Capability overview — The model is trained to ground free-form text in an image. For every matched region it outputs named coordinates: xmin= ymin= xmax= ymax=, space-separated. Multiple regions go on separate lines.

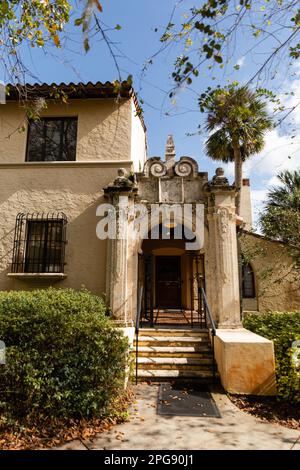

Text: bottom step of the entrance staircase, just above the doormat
xmin=138 ymin=369 xmax=213 ymax=381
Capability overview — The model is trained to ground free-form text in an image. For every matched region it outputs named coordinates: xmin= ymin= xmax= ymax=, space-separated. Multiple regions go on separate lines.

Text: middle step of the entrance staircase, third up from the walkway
xmin=138 ymin=344 xmax=212 ymax=358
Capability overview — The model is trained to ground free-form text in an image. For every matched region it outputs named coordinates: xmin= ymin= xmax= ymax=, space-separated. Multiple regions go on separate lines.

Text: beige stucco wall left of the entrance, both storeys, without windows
xmin=0 ymin=94 xmax=146 ymax=294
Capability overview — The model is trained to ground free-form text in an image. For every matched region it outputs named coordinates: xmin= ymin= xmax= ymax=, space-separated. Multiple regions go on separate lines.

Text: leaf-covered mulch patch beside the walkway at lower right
xmin=229 ymin=395 xmax=300 ymax=429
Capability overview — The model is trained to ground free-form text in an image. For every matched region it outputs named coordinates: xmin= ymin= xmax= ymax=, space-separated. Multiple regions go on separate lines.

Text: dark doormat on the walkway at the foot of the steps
xmin=157 ymin=383 xmax=221 ymax=418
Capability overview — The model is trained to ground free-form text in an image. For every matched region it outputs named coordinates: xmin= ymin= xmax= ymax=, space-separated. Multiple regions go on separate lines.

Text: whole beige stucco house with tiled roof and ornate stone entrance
xmin=0 ymin=82 xmax=300 ymax=394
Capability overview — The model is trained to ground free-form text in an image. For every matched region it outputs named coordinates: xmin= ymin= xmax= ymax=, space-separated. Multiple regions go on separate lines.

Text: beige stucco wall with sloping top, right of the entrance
xmin=241 ymin=234 xmax=300 ymax=312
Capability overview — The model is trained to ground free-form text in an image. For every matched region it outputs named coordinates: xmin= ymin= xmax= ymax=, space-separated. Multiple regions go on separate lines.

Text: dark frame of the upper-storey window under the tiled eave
xmin=25 ymin=116 xmax=78 ymax=163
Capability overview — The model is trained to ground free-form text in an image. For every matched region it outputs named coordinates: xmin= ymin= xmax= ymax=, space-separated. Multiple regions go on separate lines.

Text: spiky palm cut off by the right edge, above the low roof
xmin=260 ymin=170 xmax=300 ymax=248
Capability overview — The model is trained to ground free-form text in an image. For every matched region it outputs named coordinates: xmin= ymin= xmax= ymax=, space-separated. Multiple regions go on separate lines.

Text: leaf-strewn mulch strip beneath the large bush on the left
xmin=0 ymin=390 xmax=133 ymax=450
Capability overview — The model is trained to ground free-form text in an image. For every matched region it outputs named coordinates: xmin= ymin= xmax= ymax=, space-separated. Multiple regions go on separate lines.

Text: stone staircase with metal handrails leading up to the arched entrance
xmin=134 ymin=328 xmax=213 ymax=382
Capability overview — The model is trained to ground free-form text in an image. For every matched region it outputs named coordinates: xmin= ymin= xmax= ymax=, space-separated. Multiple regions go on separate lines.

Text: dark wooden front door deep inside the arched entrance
xmin=156 ymin=256 xmax=181 ymax=308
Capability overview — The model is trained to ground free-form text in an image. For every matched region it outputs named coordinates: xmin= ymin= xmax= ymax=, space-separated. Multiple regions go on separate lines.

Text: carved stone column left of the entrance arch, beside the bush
xmin=104 ymin=168 xmax=137 ymax=326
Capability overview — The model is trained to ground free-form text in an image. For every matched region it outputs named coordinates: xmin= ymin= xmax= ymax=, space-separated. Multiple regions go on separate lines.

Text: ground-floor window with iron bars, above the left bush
xmin=12 ymin=213 xmax=67 ymax=273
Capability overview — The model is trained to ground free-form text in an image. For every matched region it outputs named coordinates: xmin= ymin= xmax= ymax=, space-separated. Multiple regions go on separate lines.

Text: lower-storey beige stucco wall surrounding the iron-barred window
xmin=0 ymin=163 xmax=130 ymax=294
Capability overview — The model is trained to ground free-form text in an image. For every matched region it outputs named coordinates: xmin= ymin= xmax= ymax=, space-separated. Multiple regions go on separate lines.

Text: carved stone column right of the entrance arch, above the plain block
xmin=206 ymin=168 xmax=241 ymax=328
